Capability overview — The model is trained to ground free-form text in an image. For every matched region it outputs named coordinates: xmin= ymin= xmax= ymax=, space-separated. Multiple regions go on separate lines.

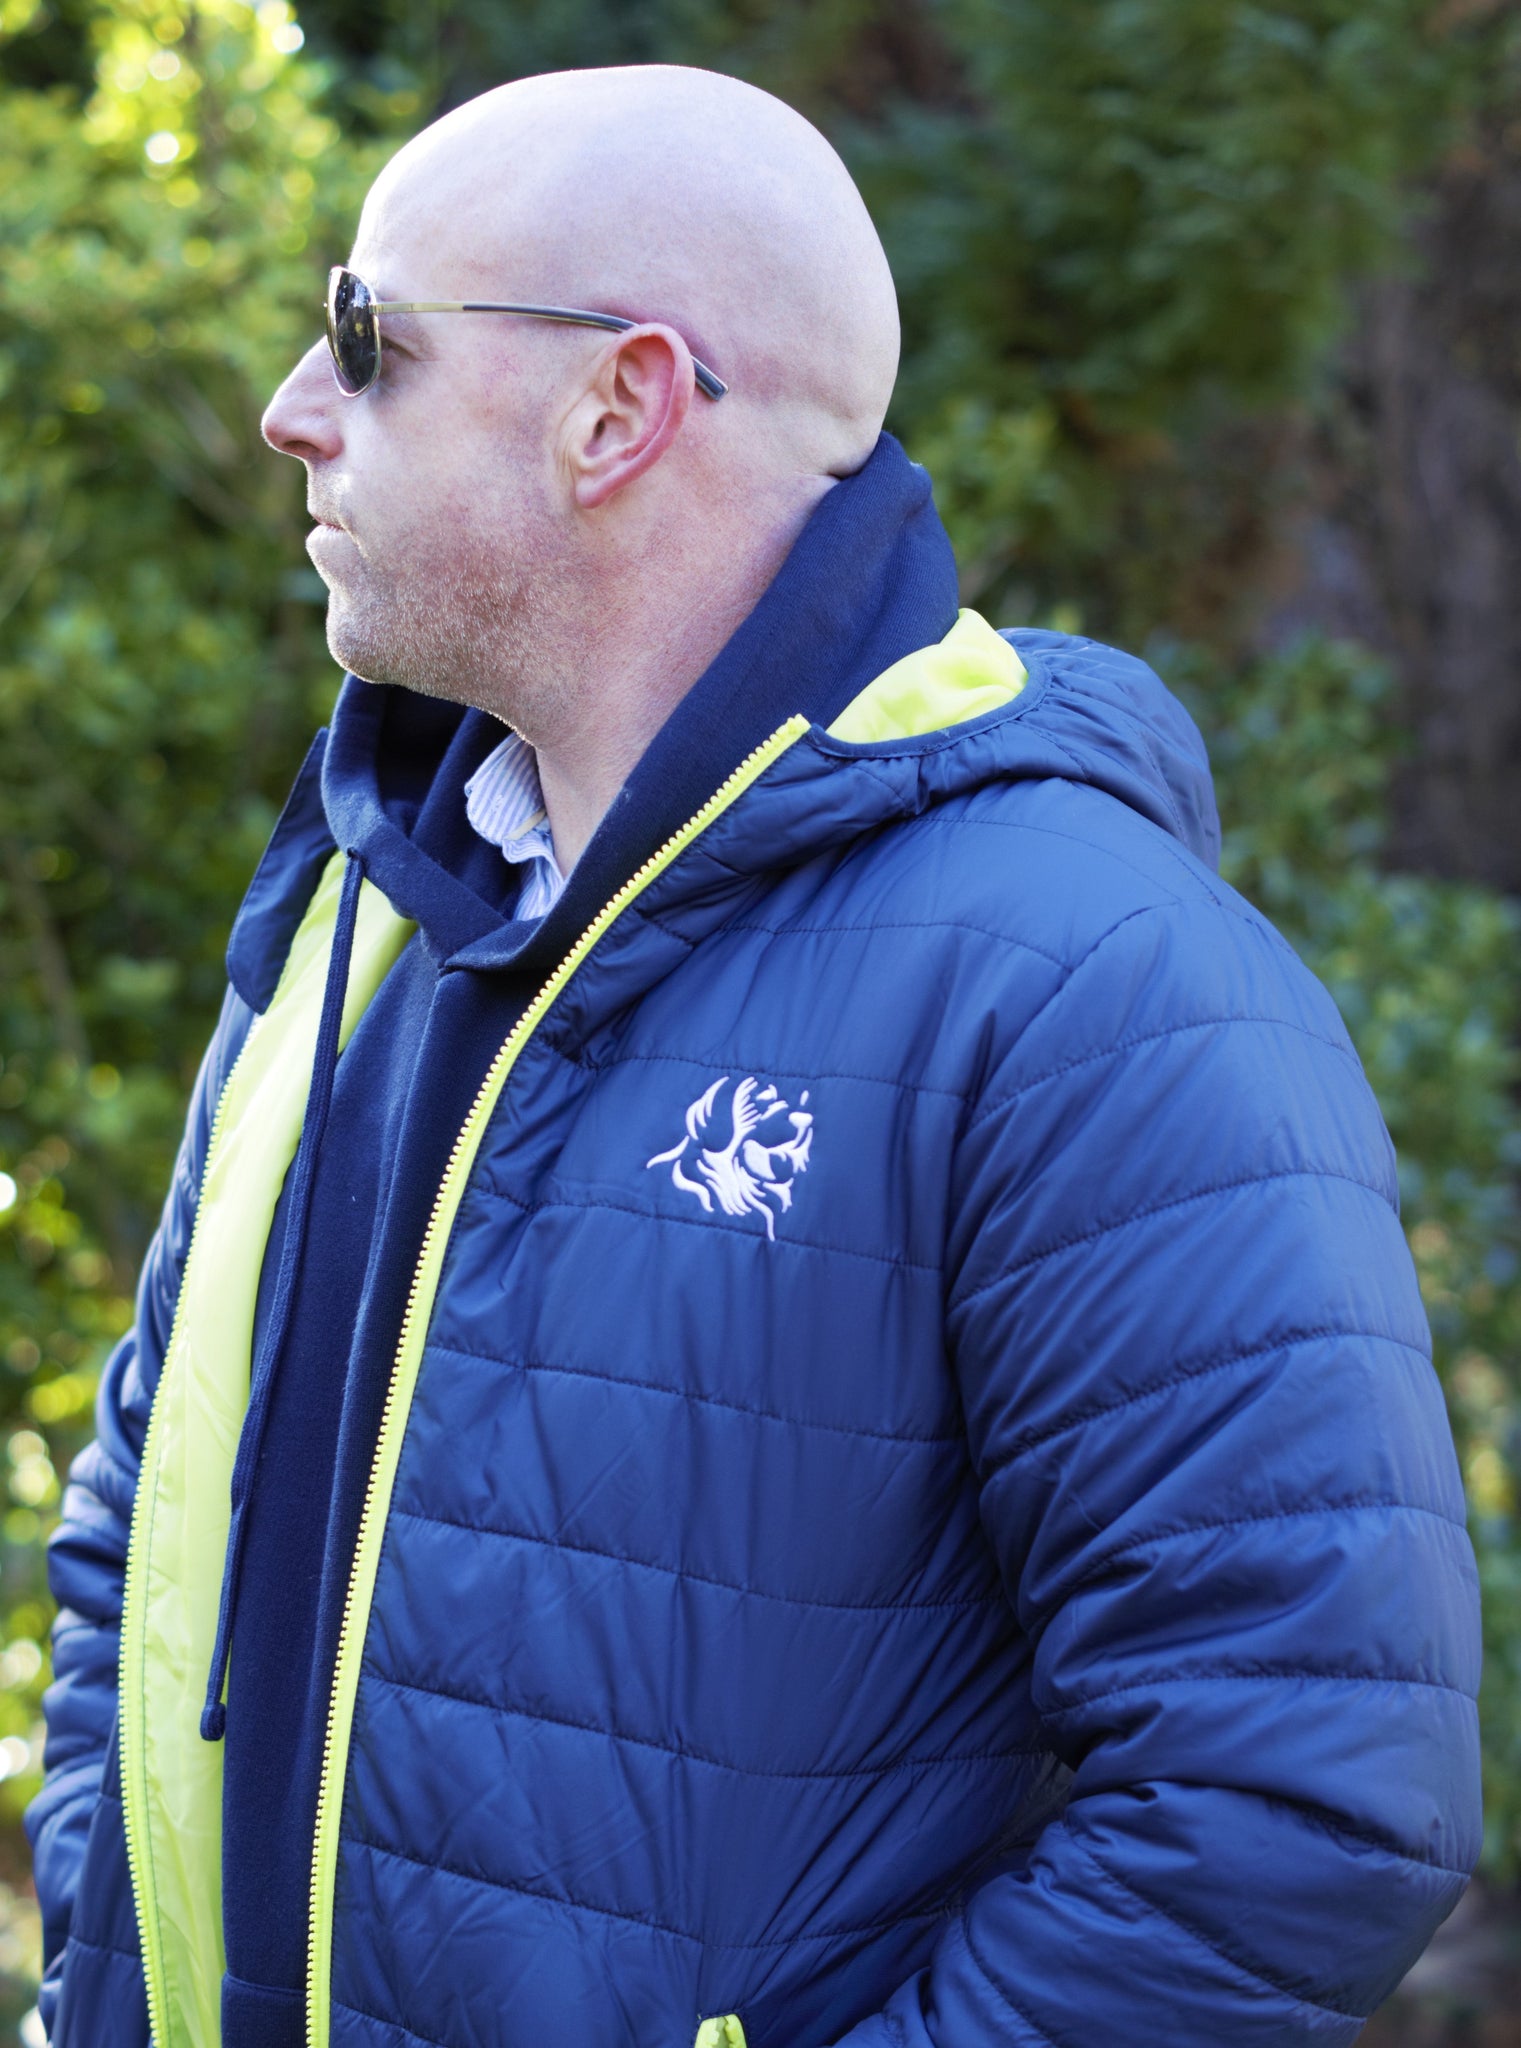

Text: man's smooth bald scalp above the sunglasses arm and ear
xmin=360 ymin=66 xmax=899 ymax=477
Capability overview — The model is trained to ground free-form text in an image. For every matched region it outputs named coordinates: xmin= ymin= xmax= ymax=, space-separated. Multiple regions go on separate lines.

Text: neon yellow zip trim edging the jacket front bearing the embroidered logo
xmin=307 ymin=715 xmax=809 ymax=2048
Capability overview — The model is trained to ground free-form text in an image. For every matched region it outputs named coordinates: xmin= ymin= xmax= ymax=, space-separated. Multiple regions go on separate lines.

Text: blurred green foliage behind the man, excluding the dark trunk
xmin=0 ymin=0 xmax=1521 ymax=2013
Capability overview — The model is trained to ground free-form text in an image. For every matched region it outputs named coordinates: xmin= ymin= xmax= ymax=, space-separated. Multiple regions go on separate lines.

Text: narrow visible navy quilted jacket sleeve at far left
xmin=27 ymin=991 xmax=252 ymax=2025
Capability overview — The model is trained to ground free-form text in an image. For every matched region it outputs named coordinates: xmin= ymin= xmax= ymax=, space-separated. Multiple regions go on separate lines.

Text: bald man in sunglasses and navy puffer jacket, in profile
xmin=29 ymin=56 xmax=1478 ymax=2048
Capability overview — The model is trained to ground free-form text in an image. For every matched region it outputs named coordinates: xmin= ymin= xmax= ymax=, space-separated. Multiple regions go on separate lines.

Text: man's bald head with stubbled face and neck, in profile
xmin=264 ymin=66 xmax=899 ymax=858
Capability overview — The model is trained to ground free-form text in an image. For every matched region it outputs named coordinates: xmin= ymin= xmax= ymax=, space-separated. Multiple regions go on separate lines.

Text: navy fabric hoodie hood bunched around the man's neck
xmin=321 ymin=434 xmax=956 ymax=973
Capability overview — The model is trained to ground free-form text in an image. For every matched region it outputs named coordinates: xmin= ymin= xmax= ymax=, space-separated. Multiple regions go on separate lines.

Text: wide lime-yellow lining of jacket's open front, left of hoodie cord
xmin=121 ymin=868 xmax=414 ymax=2048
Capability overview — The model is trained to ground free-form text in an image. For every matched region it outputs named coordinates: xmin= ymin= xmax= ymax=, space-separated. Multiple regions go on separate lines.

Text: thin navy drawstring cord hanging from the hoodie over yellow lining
xmin=201 ymin=852 xmax=364 ymax=1743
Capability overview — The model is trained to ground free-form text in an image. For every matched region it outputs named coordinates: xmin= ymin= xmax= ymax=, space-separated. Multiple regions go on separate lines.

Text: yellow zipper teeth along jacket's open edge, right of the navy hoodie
xmin=302 ymin=715 xmax=809 ymax=2048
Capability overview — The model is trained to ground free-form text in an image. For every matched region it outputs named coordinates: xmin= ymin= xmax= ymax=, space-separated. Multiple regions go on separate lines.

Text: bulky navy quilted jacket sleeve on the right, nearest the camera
xmin=831 ymin=891 xmax=1480 ymax=2048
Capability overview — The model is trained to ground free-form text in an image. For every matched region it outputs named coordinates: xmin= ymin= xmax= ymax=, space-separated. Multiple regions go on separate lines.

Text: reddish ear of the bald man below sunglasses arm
xmin=563 ymin=322 xmax=696 ymax=512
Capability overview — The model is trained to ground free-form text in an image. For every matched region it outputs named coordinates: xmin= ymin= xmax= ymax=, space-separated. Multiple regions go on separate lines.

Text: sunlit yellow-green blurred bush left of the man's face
xmin=0 ymin=0 xmax=399 ymax=1878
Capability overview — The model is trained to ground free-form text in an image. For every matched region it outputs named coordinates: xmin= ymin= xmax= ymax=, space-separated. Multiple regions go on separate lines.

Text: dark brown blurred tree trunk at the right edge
xmin=1279 ymin=121 xmax=1521 ymax=893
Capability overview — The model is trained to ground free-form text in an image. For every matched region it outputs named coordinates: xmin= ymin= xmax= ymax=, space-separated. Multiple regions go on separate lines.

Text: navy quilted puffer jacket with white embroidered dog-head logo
xmin=33 ymin=440 xmax=1478 ymax=2048
